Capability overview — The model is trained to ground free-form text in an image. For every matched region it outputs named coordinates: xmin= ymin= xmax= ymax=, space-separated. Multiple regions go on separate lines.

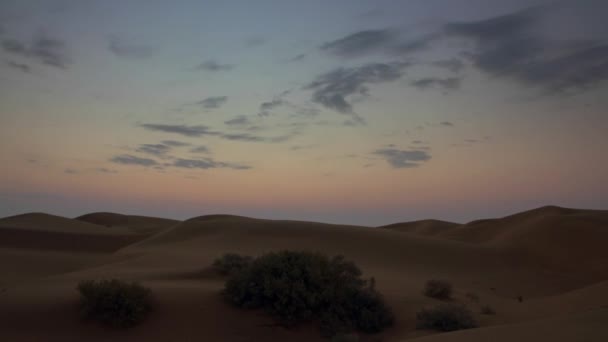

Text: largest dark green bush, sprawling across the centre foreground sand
xmin=223 ymin=251 xmax=393 ymax=336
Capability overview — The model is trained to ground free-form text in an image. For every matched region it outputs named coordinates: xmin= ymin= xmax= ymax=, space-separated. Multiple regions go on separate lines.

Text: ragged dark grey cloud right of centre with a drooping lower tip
xmin=304 ymin=63 xmax=408 ymax=119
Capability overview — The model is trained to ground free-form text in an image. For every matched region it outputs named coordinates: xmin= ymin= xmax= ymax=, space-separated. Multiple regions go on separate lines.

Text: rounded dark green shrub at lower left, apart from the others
xmin=78 ymin=279 xmax=152 ymax=328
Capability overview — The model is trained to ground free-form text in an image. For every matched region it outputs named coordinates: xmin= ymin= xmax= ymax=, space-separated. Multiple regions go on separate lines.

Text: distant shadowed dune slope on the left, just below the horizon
xmin=76 ymin=212 xmax=180 ymax=234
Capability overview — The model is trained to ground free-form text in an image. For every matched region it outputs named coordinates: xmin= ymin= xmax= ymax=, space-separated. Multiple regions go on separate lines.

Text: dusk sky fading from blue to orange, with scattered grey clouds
xmin=0 ymin=0 xmax=608 ymax=225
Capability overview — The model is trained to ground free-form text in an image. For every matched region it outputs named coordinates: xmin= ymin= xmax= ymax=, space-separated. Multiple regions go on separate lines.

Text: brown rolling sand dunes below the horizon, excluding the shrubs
xmin=0 ymin=207 xmax=608 ymax=342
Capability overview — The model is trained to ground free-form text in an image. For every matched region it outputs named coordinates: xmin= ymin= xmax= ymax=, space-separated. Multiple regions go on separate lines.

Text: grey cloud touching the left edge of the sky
xmin=2 ymin=35 xmax=71 ymax=69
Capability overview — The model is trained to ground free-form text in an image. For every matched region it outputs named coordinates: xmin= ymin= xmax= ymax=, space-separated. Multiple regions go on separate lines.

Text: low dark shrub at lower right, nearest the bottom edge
xmin=416 ymin=304 xmax=478 ymax=331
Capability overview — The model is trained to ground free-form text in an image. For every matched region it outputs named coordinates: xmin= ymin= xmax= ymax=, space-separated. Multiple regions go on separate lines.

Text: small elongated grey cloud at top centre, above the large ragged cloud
xmin=321 ymin=29 xmax=396 ymax=57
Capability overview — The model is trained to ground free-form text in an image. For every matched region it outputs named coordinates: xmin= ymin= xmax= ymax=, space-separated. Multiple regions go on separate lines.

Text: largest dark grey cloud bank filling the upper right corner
xmin=444 ymin=1 xmax=608 ymax=94
